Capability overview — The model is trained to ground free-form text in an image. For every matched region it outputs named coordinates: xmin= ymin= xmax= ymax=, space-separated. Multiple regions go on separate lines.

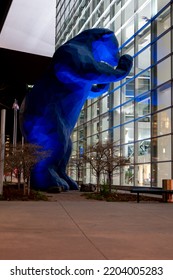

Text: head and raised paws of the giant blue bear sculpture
xmin=52 ymin=28 xmax=132 ymax=97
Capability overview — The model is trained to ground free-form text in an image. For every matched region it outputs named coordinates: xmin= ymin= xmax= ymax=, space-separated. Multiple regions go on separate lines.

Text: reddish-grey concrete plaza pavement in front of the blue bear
xmin=0 ymin=192 xmax=173 ymax=260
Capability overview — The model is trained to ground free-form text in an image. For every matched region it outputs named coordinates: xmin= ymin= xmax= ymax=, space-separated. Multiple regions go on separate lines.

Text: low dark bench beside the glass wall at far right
xmin=130 ymin=187 xmax=173 ymax=203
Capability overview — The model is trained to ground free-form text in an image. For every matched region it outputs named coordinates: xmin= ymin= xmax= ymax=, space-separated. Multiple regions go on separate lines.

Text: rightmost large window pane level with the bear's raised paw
xmin=157 ymin=57 xmax=171 ymax=85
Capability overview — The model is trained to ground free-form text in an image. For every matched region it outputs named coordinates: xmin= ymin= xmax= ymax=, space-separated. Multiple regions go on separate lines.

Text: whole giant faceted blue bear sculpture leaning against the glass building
xmin=20 ymin=28 xmax=132 ymax=190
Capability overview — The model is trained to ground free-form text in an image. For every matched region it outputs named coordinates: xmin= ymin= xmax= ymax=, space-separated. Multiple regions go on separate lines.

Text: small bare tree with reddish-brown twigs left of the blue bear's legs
xmin=5 ymin=143 xmax=50 ymax=194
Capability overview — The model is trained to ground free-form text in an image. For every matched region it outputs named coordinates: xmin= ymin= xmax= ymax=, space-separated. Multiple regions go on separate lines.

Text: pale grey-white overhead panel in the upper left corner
xmin=0 ymin=0 xmax=56 ymax=57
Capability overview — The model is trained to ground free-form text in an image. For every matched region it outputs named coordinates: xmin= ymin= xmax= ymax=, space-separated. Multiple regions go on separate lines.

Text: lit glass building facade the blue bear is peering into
xmin=56 ymin=0 xmax=173 ymax=187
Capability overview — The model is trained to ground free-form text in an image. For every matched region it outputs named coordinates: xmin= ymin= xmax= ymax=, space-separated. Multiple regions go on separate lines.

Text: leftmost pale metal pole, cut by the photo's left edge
xmin=0 ymin=109 xmax=6 ymax=195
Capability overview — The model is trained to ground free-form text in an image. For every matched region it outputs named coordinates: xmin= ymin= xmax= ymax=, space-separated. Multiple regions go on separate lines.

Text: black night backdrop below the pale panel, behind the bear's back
xmin=0 ymin=48 xmax=51 ymax=141
